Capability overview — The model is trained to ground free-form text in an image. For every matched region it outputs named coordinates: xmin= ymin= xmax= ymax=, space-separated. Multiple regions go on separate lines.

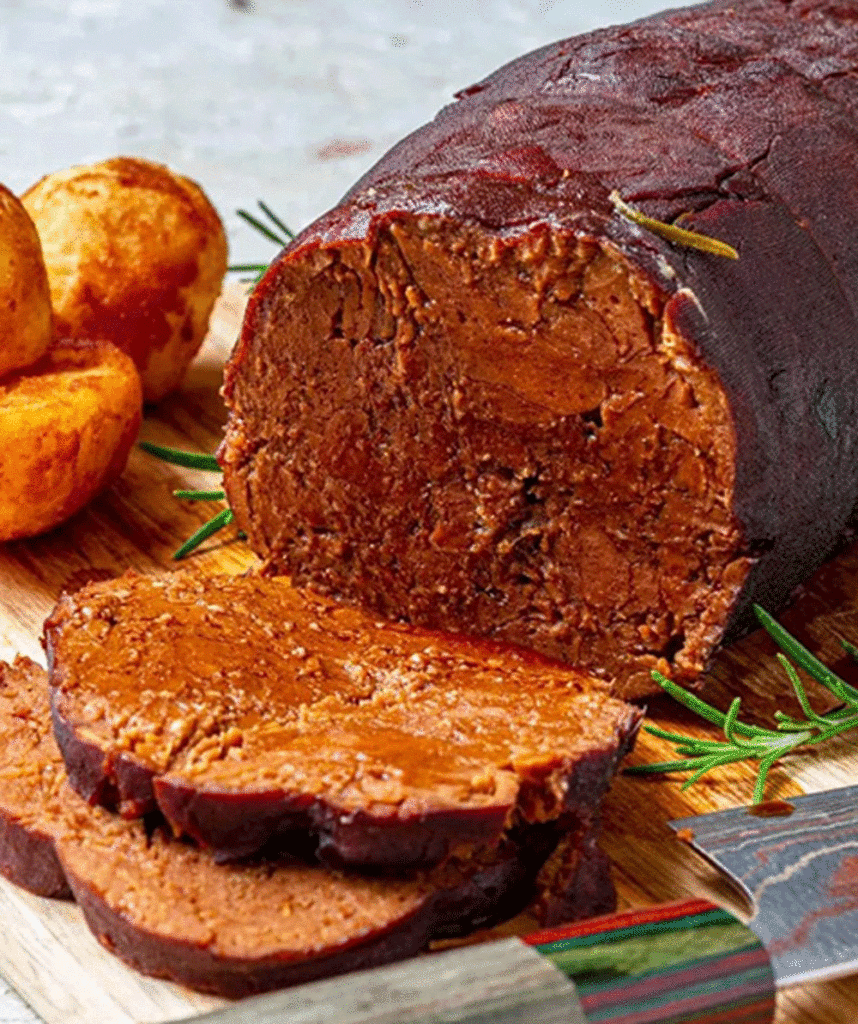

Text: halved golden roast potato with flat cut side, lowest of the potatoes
xmin=0 ymin=341 xmax=142 ymax=541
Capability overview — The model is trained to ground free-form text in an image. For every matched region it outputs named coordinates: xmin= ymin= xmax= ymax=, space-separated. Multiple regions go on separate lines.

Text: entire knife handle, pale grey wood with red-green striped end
xmin=178 ymin=900 xmax=774 ymax=1024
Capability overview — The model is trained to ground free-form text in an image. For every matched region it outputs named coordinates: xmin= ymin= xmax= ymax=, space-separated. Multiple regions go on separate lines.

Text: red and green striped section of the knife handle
xmin=524 ymin=899 xmax=775 ymax=1024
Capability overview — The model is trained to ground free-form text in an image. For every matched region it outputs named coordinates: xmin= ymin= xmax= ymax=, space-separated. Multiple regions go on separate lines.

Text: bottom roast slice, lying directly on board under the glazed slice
xmin=0 ymin=658 xmax=614 ymax=996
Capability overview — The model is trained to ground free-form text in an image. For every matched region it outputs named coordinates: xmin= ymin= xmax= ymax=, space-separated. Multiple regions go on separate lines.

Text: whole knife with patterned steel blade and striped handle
xmin=175 ymin=785 xmax=858 ymax=1024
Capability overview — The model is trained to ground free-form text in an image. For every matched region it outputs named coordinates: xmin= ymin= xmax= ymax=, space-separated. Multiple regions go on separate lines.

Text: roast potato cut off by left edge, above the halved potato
xmin=0 ymin=185 xmax=53 ymax=378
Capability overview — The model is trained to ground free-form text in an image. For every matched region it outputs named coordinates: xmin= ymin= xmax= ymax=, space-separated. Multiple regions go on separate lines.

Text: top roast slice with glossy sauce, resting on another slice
xmin=45 ymin=571 xmax=641 ymax=868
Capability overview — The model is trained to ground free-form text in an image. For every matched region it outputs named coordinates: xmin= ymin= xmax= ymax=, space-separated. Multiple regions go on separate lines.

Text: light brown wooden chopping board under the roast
xmin=0 ymin=285 xmax=858 ymax=1024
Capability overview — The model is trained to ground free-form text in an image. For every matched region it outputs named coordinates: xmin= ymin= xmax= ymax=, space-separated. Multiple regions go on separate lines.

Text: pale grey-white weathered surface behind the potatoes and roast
xmin=0 ymin=0 xmax=681 ymax=1024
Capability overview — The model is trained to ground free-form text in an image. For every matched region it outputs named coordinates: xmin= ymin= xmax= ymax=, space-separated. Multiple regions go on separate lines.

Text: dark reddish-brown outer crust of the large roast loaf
xmin=220 ymin=0 xmax=858 ymax=692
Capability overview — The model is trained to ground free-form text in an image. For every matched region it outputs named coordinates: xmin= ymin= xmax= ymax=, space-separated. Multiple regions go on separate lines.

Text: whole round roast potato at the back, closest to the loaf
xmin=22 ymin=157 xmax=226 ymax=401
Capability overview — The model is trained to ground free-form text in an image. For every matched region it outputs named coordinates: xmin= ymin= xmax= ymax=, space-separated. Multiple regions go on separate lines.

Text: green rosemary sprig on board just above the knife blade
xmin=627 ymin=605 xmax=858 ymax=804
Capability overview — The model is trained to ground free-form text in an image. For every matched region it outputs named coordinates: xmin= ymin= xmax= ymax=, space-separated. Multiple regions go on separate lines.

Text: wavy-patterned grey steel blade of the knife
xmin=670 ymin=785 xmax=858 ymax=986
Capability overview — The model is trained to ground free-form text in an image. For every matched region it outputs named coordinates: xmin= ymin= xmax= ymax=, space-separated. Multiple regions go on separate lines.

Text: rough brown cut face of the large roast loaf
xmin=220 ymin=217 xmax=748 ymax=695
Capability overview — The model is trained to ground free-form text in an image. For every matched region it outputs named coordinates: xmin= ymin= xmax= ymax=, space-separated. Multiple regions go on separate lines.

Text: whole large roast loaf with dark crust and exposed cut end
xmin=219 ymin=0 xmax=858 ymax=695
